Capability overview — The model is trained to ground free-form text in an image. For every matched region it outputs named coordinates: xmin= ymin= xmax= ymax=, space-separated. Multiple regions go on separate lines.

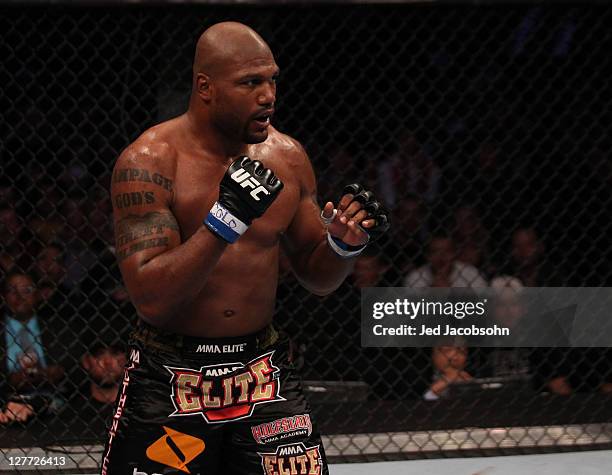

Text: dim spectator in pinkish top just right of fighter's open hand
xmin=378 ymin=130 xmax=440 ymax=209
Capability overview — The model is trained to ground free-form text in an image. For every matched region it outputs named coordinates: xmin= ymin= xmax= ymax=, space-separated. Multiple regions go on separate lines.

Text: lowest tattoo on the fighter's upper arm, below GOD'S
xmin=115 ymin=211 xmax=179 ymax=249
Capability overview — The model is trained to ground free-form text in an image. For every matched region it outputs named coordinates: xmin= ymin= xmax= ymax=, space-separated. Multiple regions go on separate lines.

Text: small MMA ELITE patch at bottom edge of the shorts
xmin=258 ymin=442 xmax=323 ymax=475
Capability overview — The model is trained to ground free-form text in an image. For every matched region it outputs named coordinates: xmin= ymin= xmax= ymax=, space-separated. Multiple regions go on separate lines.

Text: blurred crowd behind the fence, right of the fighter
xmin=280 ymin=130 xmax=612 ymax=400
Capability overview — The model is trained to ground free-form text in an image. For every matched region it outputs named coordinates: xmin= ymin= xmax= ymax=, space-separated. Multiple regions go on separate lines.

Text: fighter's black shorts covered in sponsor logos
xmin=101 ymin=323 xmax=329 ymax=475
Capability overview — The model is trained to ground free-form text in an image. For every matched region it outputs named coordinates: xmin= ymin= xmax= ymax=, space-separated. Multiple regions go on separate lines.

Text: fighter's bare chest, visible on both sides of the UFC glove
xmin=173 ymin=153 xmax=300 ymax=245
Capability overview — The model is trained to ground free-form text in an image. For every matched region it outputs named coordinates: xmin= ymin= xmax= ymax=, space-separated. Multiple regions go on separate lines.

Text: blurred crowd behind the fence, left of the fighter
xmin=0 ymin=169 xmax=131 ymax=424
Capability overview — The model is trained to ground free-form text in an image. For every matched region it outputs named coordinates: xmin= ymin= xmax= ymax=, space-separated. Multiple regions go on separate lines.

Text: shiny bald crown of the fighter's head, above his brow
xmin=193 ymin=21 xmax=272 ymax=76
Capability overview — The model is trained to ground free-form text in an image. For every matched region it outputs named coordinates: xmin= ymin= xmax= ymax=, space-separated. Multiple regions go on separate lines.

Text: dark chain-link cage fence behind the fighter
xmin=0 ymin=4 xmax=612 ymax=471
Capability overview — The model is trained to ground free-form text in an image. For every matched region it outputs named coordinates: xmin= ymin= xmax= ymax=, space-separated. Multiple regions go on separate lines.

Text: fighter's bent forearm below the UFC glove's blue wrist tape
xmin=129 ymin=227 xmax=227 ymax=323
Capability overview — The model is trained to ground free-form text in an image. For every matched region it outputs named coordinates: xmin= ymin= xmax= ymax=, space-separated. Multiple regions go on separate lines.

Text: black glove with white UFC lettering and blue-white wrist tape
xmin=204 ymin=157 xmax=283 ymax=243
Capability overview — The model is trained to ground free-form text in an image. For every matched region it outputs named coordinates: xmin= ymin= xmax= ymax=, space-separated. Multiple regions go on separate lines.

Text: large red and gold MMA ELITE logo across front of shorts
xmin=165 ymin=351 xmax=285 ymax=423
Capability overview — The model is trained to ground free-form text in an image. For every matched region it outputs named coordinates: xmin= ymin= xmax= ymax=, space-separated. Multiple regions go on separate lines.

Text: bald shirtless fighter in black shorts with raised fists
xmin=102 ymin=22 xmax=389 ymax=475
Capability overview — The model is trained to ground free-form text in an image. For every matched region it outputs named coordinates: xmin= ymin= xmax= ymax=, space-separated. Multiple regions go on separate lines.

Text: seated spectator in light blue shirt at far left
xmin=0 ymin=271 xmax=65 ymax=420
